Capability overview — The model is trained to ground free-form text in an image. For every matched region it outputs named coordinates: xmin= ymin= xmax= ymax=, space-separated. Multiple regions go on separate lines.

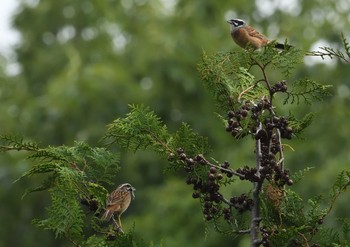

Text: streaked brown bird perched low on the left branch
xmin=102 ymin=183 xmax=136 ymax=231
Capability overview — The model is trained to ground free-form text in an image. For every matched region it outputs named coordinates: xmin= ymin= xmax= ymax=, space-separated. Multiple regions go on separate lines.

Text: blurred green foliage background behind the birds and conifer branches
xmin=0 ymin=0 xmax=350 ymax=247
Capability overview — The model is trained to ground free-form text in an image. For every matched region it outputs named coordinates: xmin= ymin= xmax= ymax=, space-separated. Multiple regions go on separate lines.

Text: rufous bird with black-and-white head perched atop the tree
xmin=227 ymin=19 xmax=291 ymax=50
